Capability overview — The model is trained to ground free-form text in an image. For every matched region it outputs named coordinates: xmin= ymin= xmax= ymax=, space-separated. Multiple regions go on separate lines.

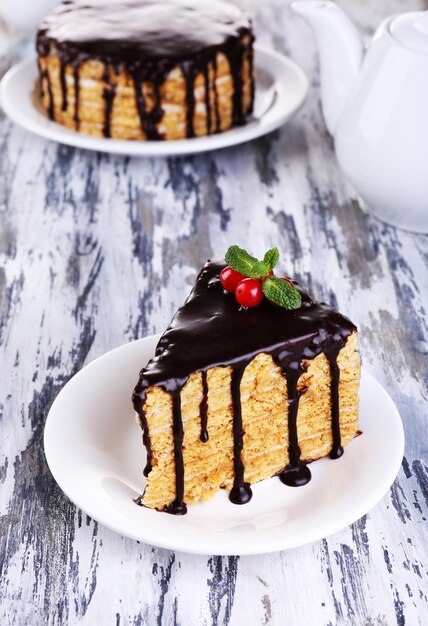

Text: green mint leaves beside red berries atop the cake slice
xmin=225 ymin=246 xmax=302 ymax=309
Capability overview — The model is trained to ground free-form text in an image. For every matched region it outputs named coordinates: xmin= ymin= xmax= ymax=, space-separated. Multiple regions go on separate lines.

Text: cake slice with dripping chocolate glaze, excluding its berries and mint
xmin=133 ymin=249 xmax=360 ymax=514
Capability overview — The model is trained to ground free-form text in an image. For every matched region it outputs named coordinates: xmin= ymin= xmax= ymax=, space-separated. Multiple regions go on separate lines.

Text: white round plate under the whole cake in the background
xmin=0 ymin=46 xmax=308 ymax=156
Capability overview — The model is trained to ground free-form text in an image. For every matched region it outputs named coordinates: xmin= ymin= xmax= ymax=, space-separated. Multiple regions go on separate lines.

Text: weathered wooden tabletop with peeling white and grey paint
xmin=0 ymin=0 xmax=428 ymax=626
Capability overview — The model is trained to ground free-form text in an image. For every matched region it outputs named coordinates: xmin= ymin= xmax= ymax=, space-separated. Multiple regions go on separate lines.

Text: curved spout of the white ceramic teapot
xmin=291 ymin=0 xmax=364 ymax=135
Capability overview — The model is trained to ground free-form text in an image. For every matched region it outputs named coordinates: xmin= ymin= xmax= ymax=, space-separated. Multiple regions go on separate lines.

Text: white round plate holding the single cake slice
xmin=44 ymin=335 xmax=404 ymax=554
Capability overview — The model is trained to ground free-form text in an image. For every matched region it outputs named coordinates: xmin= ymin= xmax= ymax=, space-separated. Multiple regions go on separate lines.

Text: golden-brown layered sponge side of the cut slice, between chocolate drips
xmin=141 ymin=333 xmax=360 ymax=509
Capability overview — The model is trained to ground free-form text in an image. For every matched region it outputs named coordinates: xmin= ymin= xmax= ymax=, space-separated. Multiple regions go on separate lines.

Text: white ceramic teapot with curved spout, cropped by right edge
xmin=292 ymin=0 xmax=428 ymax=233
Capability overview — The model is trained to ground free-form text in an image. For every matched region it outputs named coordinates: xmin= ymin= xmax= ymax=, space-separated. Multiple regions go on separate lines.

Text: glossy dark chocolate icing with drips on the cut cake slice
xmin=133 ymin=261 xmax=356 ymax=513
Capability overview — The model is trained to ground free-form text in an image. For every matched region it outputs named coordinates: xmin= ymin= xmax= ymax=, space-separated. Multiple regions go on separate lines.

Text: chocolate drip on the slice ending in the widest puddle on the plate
xmin=279 ymin=363 xmax=311 ymax=487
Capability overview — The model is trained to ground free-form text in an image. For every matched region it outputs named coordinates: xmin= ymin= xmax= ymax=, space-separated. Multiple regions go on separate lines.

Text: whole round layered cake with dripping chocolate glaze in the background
xmin=37 ymin=0 xmax=254 ymax=140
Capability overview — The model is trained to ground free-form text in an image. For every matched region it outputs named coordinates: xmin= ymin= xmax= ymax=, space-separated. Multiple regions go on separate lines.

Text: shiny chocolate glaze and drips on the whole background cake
xmin=37 ymin=0 xmax=254 ymax=139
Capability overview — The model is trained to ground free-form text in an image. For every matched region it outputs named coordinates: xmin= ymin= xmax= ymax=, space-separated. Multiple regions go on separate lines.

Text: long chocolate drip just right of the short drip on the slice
xmin=229 ymin=363 xmax=253 ymax=504
